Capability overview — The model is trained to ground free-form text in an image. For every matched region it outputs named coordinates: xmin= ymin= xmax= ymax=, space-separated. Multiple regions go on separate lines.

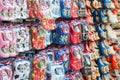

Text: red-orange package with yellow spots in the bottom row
xmin=32 ymin=54 xmax=46 ymax=80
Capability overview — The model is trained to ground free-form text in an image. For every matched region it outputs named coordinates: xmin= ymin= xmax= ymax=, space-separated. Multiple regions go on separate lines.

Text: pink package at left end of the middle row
xmin=0 ymin=28 xmax=17 ymax=58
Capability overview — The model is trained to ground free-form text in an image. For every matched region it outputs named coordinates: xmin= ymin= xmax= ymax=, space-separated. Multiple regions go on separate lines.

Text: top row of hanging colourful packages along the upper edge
xmin=0 ymin=0 xmax=119 ymax=20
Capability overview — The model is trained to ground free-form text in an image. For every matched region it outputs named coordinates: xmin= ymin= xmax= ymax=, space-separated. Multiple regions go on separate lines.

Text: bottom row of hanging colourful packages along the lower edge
xmin=0 ymin=44 xmax=120 ymax=80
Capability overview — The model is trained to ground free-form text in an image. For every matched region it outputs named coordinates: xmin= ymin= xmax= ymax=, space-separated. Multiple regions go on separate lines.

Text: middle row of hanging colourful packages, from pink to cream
xmin=0 ymin=19 xmax=118 ymax=57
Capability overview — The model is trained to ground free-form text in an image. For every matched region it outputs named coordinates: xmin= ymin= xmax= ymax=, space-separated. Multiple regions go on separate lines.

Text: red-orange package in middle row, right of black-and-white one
xmin=31 ymin=25 xmax=46 ymax=49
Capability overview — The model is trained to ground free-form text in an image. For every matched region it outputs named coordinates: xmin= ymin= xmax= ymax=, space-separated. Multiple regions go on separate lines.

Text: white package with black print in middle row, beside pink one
xmin=13 ymin=25 xmax=31 ymax=52
